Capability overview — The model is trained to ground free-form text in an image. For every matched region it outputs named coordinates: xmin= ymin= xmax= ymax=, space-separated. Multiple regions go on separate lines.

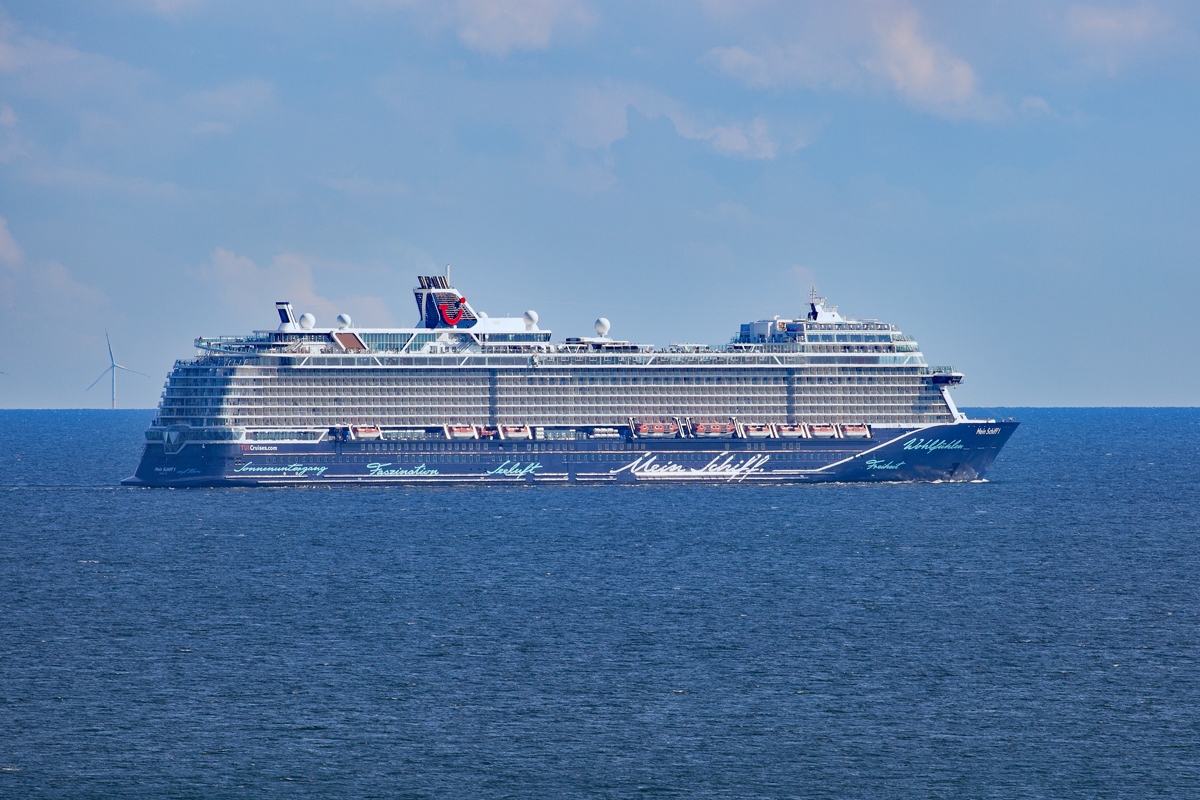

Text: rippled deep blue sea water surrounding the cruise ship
xmin=0 ymin=409 xmax=1200 ymax=798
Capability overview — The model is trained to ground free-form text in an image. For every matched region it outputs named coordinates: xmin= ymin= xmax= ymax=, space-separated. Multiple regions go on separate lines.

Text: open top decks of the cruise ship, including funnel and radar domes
xmin=196 ymin=276 xmax=953 ymax=373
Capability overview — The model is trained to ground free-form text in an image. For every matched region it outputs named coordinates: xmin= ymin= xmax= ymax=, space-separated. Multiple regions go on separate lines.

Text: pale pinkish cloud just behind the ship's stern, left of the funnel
xmin=199 ymin=247 xmax=391 ymax=326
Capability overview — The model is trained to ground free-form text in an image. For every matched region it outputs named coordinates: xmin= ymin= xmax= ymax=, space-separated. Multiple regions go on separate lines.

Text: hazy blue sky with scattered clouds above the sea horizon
xmin=0 ymin=0 xmax=1200 ymax=408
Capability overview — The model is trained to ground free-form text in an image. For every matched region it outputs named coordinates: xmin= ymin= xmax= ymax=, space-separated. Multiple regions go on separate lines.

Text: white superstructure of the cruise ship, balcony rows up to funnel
xmin=148 ymin=276 xmax=961 ymax=440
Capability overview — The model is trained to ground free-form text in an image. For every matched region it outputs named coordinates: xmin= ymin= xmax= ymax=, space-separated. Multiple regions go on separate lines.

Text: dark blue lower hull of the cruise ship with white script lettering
xmin=121 ymin=421 xmax=1018 ymax=487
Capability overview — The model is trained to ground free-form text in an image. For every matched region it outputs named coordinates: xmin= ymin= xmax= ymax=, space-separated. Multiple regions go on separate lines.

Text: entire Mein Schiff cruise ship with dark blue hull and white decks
xmin=122 ymin=270 xmax=1018 ymax=487
